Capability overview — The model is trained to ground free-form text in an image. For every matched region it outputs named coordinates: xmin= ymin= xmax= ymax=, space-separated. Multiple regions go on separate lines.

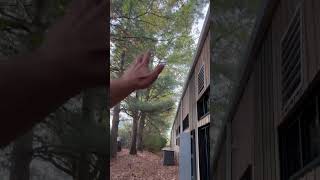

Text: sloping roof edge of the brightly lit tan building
xmin=171 ymin=5 xmax=210 ymax=129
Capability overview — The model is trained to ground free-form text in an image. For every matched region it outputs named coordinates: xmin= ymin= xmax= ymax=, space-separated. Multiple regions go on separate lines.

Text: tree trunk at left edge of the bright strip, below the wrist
xmin=110 ymin=103 xmax=120 ymax=157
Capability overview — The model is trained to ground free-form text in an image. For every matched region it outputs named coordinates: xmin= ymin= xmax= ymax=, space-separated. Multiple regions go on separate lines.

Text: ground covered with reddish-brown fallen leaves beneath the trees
xmin=110 ymin=149 xmax=178 ymax=180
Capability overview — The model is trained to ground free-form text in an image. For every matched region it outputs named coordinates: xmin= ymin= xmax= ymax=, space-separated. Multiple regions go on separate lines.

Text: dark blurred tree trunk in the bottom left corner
xmin=9 ymin=130 xmax=33 ymax=180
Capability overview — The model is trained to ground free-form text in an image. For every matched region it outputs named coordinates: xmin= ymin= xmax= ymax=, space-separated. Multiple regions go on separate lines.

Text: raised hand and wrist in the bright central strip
xmin=110 ymin=52 xmax=164 ymax=107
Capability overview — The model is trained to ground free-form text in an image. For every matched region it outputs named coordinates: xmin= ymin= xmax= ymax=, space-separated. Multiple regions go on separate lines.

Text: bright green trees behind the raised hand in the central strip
xmin=110 ymin=0 xmax=209 ymax=157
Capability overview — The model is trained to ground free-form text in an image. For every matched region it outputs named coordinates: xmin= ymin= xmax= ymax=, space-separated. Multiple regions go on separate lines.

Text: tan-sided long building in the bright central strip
xmin=171 ymin=10 xmax=210 ymax=180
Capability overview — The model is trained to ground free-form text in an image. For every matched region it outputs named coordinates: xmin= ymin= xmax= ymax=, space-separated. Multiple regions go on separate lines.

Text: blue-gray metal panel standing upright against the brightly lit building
xmin=179 ymin=132 xmax=191 ymax=180
